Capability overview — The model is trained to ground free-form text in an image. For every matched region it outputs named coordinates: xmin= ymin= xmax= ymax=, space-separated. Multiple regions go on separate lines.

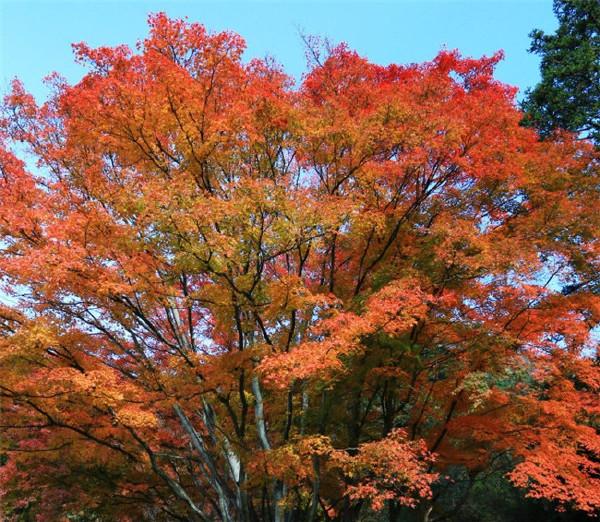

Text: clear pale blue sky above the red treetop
xmin=0 ymin=0 xmax=556 ymax=98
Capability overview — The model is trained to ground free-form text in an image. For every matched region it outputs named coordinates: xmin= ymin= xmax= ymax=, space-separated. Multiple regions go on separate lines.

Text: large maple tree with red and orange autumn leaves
xmin=0 ymin=14 xmax=600 ymax=522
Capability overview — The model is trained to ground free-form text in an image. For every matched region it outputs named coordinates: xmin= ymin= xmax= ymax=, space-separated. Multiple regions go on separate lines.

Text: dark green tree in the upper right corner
xmin=523 ymin=0 xmax=600 ymax=145
